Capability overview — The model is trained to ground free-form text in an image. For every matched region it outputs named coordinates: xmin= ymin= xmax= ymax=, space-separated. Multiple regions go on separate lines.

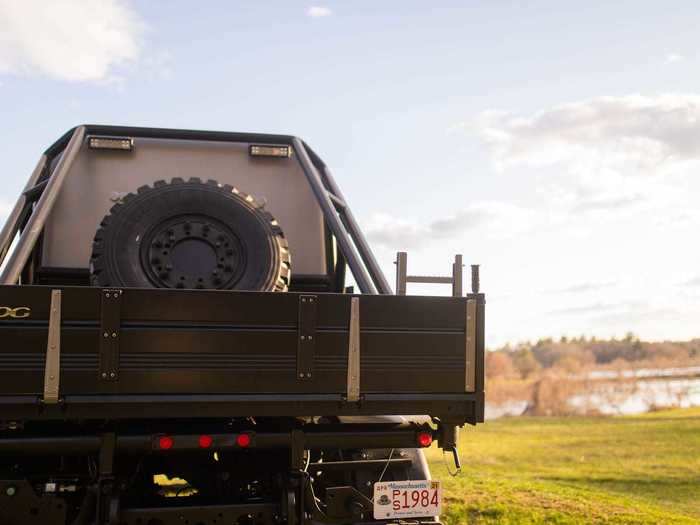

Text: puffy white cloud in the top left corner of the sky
xmin=0 ymin=0 xmax=144 ymax=81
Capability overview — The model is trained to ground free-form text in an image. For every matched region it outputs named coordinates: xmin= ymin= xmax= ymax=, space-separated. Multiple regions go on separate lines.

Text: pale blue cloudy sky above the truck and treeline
xmin=0 ymin=0 xmax=700 ymax=347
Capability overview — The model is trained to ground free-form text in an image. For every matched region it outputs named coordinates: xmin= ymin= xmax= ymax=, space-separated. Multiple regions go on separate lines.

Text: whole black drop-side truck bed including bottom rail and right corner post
xmin=0 ymin=286 xmax=484 ymax=424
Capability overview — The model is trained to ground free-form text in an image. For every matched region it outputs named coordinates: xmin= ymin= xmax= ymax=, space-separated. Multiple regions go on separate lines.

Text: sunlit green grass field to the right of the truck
xmin=428 ymin=409 xmax=700 ymax=524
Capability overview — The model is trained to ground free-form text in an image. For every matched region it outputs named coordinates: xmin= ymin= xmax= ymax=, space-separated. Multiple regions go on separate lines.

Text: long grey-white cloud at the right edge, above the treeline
xmin=477 ymin=94 xmax=700 ymax=167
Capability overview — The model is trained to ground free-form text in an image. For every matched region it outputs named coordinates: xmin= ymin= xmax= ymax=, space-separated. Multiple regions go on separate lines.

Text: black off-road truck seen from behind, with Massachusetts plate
xmin=0 ymin=125 xmax=484 ymax=525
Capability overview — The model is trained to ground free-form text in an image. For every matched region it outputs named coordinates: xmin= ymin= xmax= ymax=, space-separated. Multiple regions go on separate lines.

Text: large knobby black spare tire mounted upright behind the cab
xmin=90 ymin=178 xmax=290 ymax=291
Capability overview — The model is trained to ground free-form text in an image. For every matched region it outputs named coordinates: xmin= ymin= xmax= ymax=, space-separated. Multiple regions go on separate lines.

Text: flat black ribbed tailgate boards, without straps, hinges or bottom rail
xmin=0 ymin=286 xmax=478 ymax=399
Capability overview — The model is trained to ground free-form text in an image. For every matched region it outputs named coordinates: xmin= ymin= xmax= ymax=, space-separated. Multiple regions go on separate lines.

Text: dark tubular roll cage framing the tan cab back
xmin=0 ymin=124 xmax=393 ymax=294
